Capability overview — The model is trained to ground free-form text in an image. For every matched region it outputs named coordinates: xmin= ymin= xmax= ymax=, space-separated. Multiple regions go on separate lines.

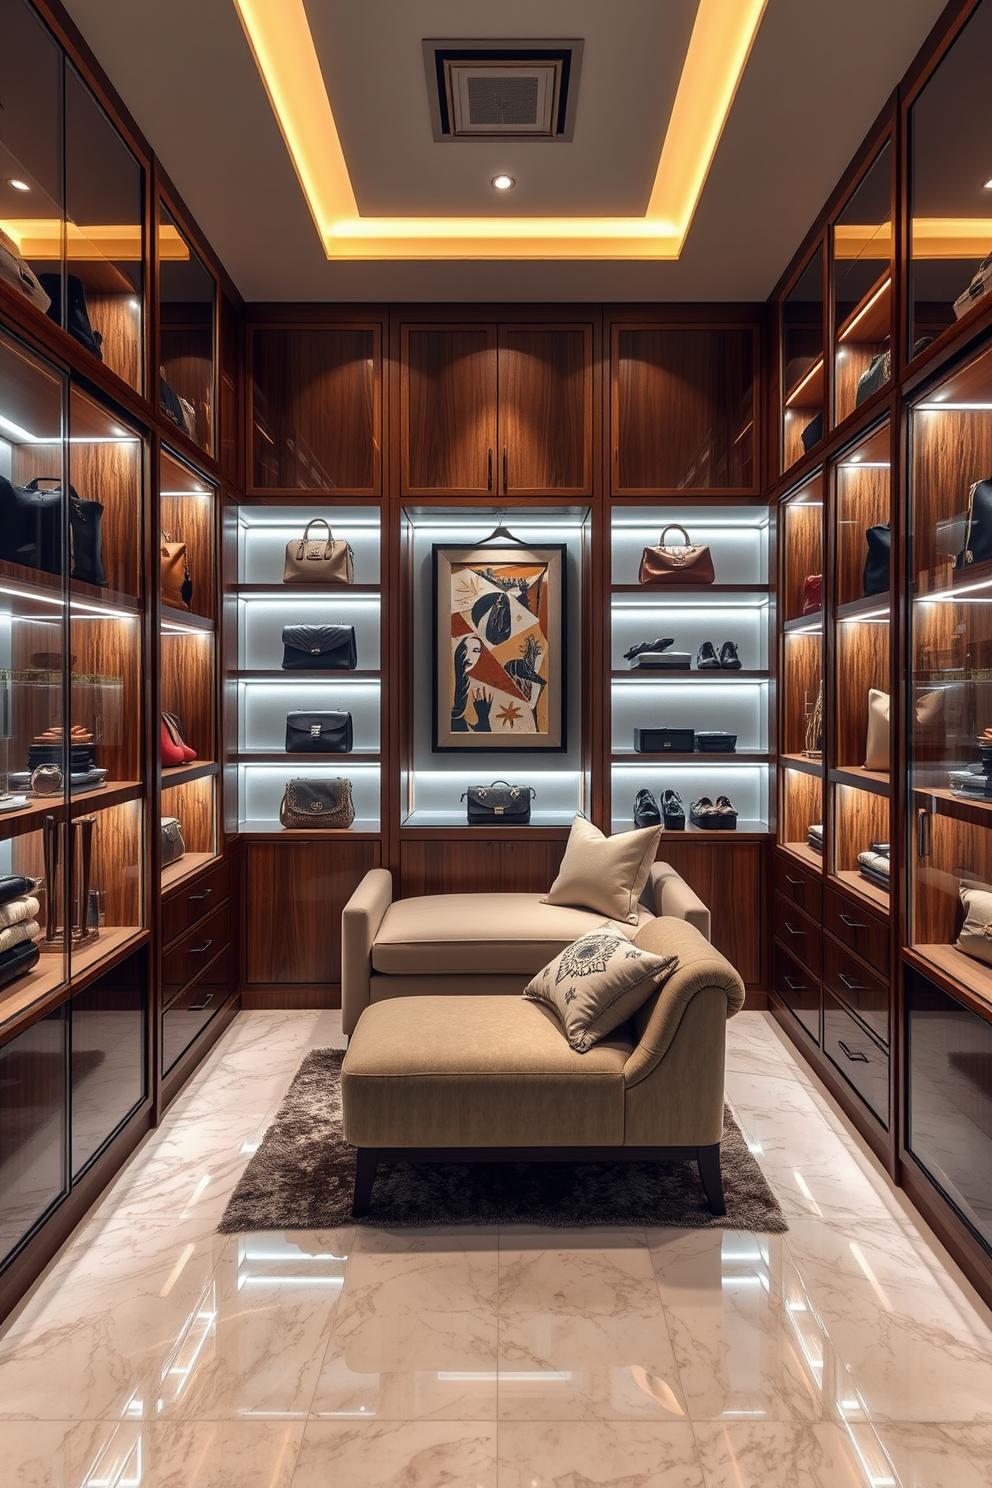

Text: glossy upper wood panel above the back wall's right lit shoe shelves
xmin=611 ymin=326 xmax=756 ymax=494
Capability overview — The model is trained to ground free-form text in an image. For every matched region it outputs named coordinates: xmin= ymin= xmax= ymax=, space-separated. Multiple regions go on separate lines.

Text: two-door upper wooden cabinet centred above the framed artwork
xmin=400 ymin=324 xmax=592 ymax=496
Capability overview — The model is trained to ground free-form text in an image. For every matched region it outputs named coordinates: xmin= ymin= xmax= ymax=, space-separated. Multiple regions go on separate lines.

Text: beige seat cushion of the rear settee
xmin=372 ymin=894 xmax=653 ymax=976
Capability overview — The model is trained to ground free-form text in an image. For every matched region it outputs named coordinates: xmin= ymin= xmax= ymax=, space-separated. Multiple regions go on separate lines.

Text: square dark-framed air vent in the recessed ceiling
xmin=424 ymin=40 xmax=582 ymax=140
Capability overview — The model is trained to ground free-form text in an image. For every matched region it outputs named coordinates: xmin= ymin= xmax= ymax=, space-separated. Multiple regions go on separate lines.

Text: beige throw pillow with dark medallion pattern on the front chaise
xmin=524 ymin=920 xmax=678 ymax=1054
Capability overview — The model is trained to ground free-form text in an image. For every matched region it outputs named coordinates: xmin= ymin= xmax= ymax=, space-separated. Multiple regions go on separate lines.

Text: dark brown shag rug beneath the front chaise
xmin=219 ymin=1049 xmax=788 ymax=1235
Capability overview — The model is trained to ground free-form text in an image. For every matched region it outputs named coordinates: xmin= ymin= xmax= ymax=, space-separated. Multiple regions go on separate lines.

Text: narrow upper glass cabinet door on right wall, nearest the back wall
xmin=781 ymin=243 xmax=825 ymax=470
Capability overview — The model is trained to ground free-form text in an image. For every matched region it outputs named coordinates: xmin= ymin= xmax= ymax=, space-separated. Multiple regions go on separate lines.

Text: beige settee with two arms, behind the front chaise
xmin=341 ymin=863 xmax=709 ymax=1034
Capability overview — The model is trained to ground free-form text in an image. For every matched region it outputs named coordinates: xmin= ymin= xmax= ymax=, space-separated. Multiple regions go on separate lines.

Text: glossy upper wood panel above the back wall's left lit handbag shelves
xmin=251 ymin=326 xmax=382 ymax=496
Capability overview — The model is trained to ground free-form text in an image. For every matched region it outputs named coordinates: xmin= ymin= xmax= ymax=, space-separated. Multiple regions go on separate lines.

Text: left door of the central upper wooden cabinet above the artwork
xmin=400 ymin=326 xmax=497 ymax=496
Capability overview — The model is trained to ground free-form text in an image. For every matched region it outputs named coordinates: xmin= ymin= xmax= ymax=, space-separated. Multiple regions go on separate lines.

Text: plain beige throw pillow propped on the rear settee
xmin=541 ymin=817 xmax=662 ymax=926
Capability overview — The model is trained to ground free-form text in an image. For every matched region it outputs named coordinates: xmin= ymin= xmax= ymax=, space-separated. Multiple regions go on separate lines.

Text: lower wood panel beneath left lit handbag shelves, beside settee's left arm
xmin=245 ymin=841 xmax=379 ymax=985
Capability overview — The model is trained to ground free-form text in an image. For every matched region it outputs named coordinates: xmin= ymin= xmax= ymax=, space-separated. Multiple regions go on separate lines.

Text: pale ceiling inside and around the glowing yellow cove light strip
xmin=64 ymin=0 xmax=944 ymax=301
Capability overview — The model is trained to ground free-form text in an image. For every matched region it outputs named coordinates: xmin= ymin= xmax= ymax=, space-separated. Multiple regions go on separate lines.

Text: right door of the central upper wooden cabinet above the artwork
xmin=497 ymin=326 xmax=592 ymax=496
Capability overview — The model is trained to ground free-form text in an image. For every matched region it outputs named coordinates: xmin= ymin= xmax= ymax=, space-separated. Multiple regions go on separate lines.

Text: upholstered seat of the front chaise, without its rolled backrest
xmin=341 ymin=999 xmax=634 ymax=1147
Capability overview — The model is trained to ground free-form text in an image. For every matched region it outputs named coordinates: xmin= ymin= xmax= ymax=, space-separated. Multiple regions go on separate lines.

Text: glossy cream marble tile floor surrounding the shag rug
xmin=0 ymin=1013 xmax=992 ymax=1488
